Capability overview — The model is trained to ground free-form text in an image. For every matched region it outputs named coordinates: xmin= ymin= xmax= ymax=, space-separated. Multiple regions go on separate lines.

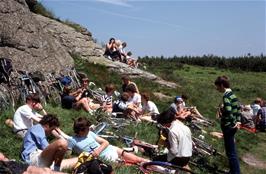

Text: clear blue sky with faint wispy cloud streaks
xmin=39 ymin=0 xmax=266 ymax=56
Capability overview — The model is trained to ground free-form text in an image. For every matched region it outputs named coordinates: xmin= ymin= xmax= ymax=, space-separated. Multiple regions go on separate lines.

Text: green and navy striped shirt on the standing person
xmin=221 ymin=88 xmax=241 ymax=127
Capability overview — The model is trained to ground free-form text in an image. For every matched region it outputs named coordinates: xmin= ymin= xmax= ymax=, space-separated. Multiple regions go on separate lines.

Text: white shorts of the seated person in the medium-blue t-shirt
xmin=29 ymin=149 xmax=50 ymax=167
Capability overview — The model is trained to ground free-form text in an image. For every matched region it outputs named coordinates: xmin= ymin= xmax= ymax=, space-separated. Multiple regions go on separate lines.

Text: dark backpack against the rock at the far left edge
xmin=0 ymin=58 xmax=13 ymax=83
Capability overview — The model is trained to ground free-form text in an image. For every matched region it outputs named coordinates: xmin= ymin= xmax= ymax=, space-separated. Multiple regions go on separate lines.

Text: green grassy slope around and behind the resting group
xmin=0 ymin=60 xmax=266 ymax=173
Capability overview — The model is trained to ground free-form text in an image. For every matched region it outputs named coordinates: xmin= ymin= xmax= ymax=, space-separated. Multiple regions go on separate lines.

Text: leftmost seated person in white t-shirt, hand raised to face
xmin=9 ymin=94 xmax=46 ymax=138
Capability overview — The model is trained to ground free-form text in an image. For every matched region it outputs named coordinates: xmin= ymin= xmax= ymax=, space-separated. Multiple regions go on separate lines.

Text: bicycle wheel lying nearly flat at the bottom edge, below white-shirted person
xmin=141 ymin=161 xmax=194 ymax=174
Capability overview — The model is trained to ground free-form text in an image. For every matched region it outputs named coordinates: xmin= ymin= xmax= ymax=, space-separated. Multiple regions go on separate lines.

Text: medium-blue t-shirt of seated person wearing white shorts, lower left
xmin=21 ymin=124 xmax=49 ymax=163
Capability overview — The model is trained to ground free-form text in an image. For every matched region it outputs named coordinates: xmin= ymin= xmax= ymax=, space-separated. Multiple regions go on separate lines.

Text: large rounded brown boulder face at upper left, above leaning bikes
xmin=0 ymin=0 xmax=73 ymax=71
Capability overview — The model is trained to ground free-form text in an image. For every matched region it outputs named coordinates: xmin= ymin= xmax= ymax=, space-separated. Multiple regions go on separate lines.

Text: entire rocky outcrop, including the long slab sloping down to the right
xmin=0 ymin=0 xmax=178 ymax=88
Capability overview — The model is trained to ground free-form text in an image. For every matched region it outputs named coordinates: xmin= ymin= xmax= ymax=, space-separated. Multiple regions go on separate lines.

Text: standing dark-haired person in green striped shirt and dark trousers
xmin=214 ymin=76 xmax=241 ymax=174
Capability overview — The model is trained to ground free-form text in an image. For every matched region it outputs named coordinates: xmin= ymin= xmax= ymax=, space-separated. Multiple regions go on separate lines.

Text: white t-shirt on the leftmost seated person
xmin=13 ymin=105 xmax=41 ymax=132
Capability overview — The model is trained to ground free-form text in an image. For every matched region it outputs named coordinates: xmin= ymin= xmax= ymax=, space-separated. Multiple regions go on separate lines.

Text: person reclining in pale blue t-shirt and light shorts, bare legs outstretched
xmin=68 ymin=117 xmax=148 ymax=163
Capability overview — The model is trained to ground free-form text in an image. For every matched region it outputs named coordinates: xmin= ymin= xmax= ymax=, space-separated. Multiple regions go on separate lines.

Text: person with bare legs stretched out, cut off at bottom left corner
xmin=0 ymin=152 xmax=63 ymax=174
